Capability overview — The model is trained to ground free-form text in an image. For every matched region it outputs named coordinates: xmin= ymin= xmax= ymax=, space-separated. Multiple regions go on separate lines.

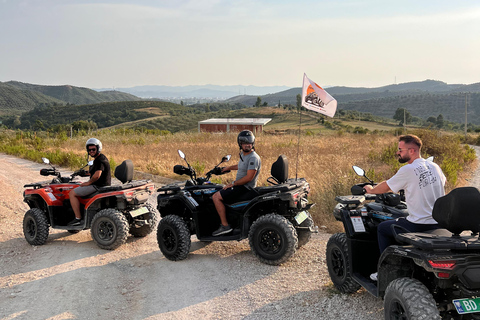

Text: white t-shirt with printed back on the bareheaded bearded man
xmin=387 ymin=158 xmax=447 ymax=224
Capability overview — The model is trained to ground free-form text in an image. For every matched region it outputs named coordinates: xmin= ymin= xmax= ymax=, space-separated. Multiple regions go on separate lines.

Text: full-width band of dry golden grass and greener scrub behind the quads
xmin=3 ymin=130 xmax=476 ymax=232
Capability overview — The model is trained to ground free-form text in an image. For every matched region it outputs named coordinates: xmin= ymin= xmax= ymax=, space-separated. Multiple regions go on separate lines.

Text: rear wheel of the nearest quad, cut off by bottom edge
xmin=383 ymin=278 xmax=440 ymax=320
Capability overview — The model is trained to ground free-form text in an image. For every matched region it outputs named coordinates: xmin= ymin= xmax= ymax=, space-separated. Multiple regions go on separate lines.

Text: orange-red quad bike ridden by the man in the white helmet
xmin=23 ymin=158 xmax=159 ymax=250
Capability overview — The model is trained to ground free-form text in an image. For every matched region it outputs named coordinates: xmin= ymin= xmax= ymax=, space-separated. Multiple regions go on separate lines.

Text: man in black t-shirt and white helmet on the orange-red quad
xmin=68 ymin=138 xmax=112 ymax=226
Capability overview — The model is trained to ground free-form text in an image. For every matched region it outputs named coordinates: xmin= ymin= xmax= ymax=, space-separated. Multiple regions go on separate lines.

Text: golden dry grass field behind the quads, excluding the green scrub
xmin=48 ymin=133 xmax=402 ymax=232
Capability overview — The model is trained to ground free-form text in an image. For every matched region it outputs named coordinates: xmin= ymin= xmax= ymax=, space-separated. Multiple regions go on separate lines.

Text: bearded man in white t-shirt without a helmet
xmin=365 ymin=135 xmax=446 ymax=253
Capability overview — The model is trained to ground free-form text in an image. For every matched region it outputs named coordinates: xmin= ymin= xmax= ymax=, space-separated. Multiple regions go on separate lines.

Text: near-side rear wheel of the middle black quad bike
xmin=248 ymin=213 xmax=298 ymax=266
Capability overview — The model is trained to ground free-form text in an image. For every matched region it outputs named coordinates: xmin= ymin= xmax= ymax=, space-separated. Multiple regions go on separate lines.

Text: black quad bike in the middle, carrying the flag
xmin=157 ymin=150 xmax=315 ymax=265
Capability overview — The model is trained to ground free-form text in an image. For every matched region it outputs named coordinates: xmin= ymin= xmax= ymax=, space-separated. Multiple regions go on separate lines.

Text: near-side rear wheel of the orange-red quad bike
xmin=91 ymin=209 xmax=128 ymax=250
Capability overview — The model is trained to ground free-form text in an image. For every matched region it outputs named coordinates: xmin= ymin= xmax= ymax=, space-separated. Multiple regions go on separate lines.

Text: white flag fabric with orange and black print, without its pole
xmin=302 ymin=73 xmax=337 ymax=118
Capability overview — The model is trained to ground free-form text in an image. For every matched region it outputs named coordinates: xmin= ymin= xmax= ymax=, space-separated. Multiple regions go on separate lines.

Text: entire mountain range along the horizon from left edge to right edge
xmin=0 ymin=80 xmax=480 ymax=125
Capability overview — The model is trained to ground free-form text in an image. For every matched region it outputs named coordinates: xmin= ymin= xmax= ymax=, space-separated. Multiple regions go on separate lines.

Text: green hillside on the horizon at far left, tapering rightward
xmin=0 ymin=81 xmax=140 ymax=115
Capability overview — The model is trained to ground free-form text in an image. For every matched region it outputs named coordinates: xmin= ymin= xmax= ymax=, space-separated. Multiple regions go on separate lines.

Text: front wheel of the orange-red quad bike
xmin=23 ymin=208 xmax=49 ymax=246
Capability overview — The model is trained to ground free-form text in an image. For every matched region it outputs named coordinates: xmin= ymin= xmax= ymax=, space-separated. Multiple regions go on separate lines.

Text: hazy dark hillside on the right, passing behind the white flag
xmin=227 ymin=80 xmax=480 ymax=125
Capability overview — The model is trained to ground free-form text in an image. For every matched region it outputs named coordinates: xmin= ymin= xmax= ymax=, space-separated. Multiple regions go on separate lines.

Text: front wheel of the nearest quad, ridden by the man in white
xmin=325 ymin=233 xmax=360 ymax=293
